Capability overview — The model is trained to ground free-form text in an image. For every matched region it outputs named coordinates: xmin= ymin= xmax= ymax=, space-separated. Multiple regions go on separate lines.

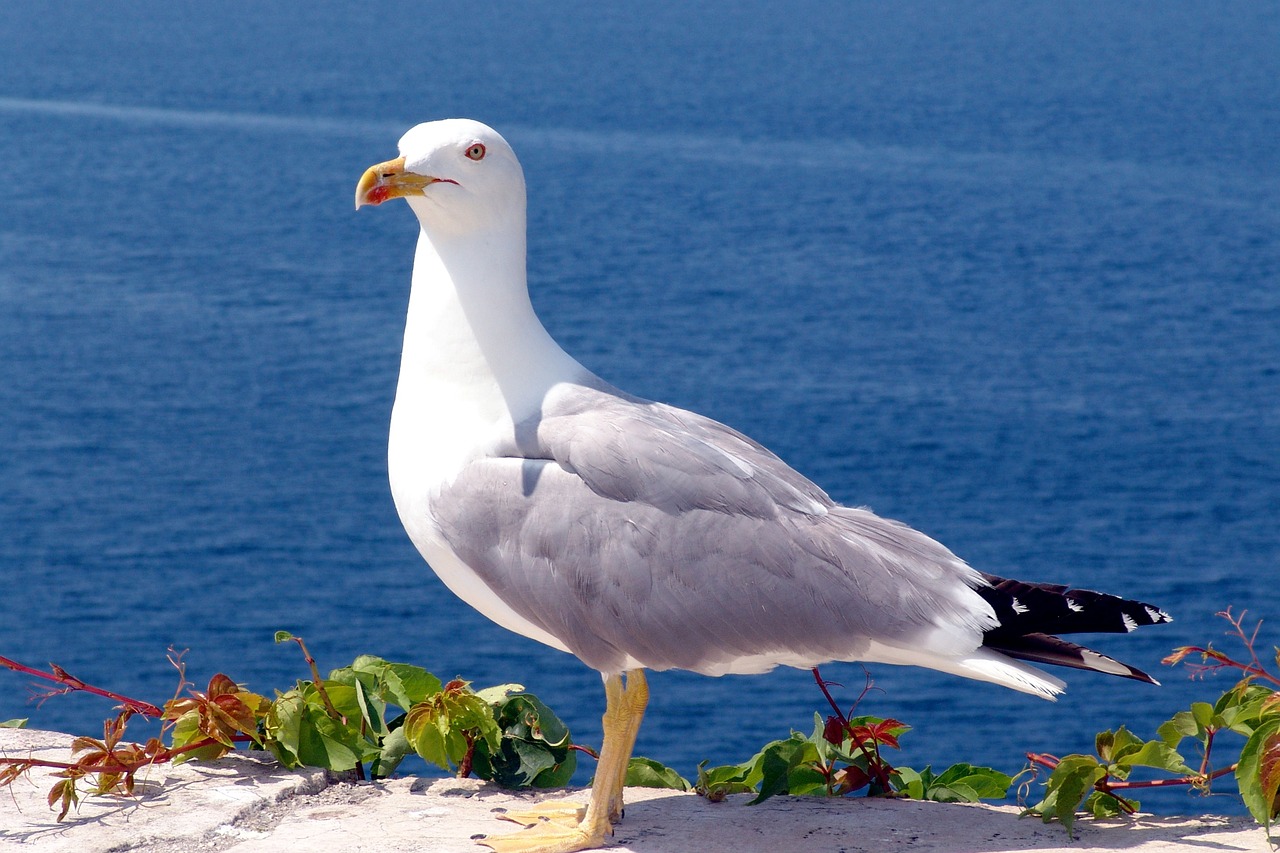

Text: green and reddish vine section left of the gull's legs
xmin=0 ymin=631 xmax=581 ymax=821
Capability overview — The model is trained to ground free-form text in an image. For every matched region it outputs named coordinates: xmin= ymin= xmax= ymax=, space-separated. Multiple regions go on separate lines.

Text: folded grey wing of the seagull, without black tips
xmin=431 ymin=388 xmax=995 ymax=674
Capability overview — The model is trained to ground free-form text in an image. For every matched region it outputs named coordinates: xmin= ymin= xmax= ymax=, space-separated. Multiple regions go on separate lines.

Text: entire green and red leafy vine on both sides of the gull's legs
xmin=0 ymin=611 xmax=1280 ymax=834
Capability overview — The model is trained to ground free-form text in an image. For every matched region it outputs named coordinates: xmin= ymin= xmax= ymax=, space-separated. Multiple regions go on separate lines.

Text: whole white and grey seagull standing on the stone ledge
xmin=356 ymin=119 xmax=1170 ymax=853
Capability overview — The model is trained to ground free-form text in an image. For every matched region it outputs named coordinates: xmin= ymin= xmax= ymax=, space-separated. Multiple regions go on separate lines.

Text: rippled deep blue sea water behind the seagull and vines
xmin=0 ymin=0 xmax=1280 ymax=812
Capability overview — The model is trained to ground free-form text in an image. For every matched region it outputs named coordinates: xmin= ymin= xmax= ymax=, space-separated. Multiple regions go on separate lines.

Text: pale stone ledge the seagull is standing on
xmin=0 ymin=729 xmax=1272 ymax=853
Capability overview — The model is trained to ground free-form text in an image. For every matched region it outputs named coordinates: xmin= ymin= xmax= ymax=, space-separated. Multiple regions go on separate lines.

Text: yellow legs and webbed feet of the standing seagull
xmin=480 ymin=670 xmax=649 ymax=853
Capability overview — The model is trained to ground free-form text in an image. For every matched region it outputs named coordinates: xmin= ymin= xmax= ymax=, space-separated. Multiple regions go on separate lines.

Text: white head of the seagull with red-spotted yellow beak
xmin=356 ymin=119 xmax=525 ymax=236
